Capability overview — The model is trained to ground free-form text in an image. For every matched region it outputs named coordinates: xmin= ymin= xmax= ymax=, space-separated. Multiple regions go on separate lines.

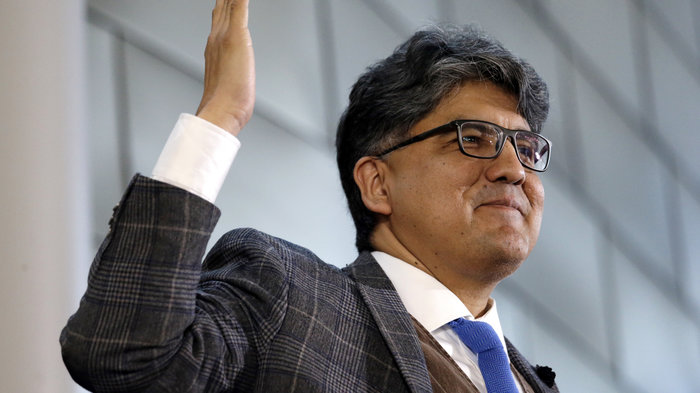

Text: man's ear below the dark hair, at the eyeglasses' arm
xmin=353 ymin=156 xmax=391 ymax=216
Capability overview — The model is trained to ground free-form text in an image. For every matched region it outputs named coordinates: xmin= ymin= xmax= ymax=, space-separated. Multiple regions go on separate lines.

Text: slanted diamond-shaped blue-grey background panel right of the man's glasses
xmin=577 ymin=70 xmax=671 ymax=274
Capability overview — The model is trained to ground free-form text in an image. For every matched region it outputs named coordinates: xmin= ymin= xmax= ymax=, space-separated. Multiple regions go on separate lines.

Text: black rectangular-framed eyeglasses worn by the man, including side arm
xmin=377 ymin=120 xmax=552 ymax=172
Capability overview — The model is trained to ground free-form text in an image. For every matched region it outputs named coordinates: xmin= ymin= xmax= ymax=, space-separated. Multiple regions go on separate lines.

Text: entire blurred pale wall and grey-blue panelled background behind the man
xmin=0 ymin=0 xmax=700 ymax=393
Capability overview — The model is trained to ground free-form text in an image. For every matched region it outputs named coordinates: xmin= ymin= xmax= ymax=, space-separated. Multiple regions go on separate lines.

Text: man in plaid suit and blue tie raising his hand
xmin=61 ymin=0 xmax=558 ymax=392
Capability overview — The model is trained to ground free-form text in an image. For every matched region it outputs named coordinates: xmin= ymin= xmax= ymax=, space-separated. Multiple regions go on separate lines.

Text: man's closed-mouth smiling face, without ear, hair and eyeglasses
xmin=384 ymin=82 xmax=544 ymax=286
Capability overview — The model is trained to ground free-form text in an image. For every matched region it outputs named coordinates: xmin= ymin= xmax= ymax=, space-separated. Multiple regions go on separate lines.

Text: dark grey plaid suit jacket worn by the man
xmin=60 ymin=176 xmax=549 ymax=392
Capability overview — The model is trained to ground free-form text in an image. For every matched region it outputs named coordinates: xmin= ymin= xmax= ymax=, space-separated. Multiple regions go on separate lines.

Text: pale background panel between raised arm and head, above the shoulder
xmin=212 ymin=115 xmax=357 ymax=266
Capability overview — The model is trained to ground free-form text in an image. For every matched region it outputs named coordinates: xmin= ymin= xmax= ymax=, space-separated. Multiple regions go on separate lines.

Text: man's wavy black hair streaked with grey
xmin=336 ymin=26 xmax=549 ymax=251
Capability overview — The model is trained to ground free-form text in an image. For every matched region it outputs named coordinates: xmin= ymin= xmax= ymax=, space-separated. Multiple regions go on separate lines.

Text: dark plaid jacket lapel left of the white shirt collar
xmin=343 ymin=251 xmax=432 ymax=393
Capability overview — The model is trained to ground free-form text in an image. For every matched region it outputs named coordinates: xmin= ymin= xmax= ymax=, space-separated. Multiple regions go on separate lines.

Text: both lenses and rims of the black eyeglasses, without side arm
xmin=460 ymin=122 xmax=549 ymax=171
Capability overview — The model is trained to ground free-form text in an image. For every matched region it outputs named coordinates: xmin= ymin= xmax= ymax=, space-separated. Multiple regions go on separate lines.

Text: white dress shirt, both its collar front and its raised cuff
xmin=153 ymin=113 xmax=523 ymax=393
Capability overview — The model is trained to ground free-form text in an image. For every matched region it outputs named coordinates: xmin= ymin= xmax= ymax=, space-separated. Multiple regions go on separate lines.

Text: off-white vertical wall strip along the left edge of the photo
xmin=0 ymin=0 xmax=92 ymax=393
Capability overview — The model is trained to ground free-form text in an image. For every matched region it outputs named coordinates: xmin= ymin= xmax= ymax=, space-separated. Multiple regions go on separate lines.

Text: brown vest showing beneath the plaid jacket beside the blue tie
xmin=411 ymin=317 xmax=534 ymax=393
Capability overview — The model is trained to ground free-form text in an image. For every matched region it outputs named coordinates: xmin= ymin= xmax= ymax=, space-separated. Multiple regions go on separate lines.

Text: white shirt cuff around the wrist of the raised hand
xmin=153 ymin=113 xmax=241 ymax=203
